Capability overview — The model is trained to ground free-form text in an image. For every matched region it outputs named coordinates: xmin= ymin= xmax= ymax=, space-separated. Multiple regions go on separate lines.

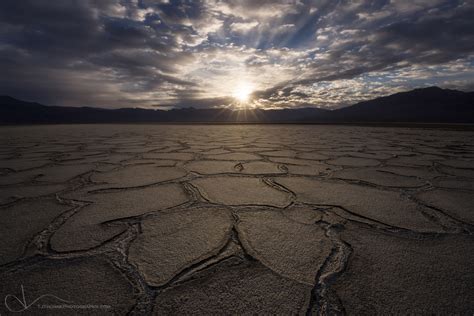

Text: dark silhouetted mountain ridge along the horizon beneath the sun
xmin=0 ymin=87 xmax=474 ymax=125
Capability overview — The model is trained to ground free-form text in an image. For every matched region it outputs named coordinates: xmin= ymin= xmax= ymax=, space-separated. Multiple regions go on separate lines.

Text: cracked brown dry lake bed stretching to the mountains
xmin=0 ymin=125 xmax=474 ymax=315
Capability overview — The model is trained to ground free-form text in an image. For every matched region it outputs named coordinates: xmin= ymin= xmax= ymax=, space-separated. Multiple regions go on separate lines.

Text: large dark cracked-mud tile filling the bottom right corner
xmin=331 ymin=227 xmax=474 ymax=315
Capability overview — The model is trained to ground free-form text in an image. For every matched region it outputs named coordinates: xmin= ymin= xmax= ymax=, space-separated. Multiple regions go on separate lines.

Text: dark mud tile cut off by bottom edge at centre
xmin=153 ymin=260 xmax=312 ymax=315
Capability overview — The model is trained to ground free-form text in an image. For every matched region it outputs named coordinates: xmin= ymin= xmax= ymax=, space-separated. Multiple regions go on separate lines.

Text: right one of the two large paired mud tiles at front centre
xmin=237 ymin=211 xmax=332 ymax=285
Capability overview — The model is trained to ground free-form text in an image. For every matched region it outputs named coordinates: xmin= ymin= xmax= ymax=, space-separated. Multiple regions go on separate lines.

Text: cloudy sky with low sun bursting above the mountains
xmin=0 ymin=0 xmax=474 ymax=109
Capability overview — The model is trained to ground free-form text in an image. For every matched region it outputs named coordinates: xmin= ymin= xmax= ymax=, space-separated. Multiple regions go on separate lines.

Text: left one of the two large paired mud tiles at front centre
xmin=129 ymin=207 xmax=233 ymax=286
